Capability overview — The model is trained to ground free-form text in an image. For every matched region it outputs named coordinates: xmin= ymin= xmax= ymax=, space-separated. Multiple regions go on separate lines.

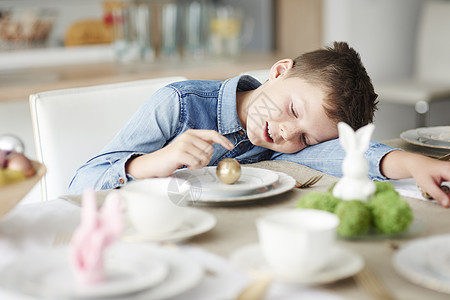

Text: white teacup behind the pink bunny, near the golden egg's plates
xmin=120 ymin=178 xmax=190 ymax=235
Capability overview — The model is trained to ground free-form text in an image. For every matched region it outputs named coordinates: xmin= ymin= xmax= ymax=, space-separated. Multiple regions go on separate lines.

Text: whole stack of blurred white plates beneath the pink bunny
xmin=0 ymin=243 xmax=204 ymax=300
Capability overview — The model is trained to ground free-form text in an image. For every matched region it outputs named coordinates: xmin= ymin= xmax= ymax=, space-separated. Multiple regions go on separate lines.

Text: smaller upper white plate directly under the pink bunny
xmin=0 ymin=244 xmax=169 ymax=299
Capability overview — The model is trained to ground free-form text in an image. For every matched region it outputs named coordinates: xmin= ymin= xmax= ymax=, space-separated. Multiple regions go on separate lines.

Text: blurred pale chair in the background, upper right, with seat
xmin=374 ymin=1 xmax=450 ymax=127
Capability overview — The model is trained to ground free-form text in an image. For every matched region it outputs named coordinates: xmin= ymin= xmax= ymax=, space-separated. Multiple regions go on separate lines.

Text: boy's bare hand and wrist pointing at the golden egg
xmin=127 ymin=129 xmax=234 ymax=179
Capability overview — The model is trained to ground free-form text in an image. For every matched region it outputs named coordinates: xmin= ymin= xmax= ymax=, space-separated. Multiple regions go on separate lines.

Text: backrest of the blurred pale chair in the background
xmin=416 ymin=1 xmax=450 ymax=82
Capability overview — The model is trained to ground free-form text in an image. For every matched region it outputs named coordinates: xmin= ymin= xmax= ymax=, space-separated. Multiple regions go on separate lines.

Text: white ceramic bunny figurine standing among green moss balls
xmin=333 ymin=122 xmax=376 ymax=201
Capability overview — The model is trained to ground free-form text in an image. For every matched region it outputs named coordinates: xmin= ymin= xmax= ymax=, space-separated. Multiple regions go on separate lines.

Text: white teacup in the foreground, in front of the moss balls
xmin=256 ymin=209 xmax=339 ymax=280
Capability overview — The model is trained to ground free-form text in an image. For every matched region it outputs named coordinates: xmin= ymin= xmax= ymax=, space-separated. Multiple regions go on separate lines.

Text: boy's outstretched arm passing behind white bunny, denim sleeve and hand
xmin=272 ymin=139 xmax=450 ymax=207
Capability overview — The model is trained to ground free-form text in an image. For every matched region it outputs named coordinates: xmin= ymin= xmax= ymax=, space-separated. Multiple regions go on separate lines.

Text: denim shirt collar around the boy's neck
xmin=217 ymin=75 xmax=261 ymax=134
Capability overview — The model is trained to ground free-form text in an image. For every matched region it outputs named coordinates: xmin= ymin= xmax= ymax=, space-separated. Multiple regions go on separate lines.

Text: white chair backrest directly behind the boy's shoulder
xmin=30 ymin=77 xmax=185 ymax=200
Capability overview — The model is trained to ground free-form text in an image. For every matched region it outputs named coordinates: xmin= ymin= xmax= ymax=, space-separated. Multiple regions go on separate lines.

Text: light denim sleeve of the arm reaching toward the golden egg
xmin=69 ymin=87 xmax=179 ymax=194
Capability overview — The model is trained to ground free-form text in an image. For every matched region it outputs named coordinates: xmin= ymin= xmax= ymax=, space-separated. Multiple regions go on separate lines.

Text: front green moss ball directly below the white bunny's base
xmin=334 ymin=200 xmax=372 ymax=237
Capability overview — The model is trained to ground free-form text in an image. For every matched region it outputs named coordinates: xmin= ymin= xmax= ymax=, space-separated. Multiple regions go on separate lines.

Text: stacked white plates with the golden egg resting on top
xmin=173 ymin=167 xmax=295 ymax=203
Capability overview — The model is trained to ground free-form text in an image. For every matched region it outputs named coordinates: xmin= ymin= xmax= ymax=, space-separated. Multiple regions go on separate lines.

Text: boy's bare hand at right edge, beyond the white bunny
xmin=381 ymin=151 xmax=450 ymax=207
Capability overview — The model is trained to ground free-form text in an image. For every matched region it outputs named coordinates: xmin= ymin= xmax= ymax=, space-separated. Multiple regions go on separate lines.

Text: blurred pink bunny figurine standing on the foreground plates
xmin=69 ymin=191 xmax=123 ymax=285
